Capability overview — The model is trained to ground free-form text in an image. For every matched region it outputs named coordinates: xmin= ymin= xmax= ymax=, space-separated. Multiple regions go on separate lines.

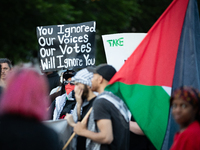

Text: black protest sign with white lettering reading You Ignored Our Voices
xmin=37 ymin=21 xmax=96 ymax=72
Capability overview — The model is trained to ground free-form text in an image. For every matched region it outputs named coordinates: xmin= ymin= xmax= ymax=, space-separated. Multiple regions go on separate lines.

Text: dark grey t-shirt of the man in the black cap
xmin=93 ymin=98 xmax=130 ymax=150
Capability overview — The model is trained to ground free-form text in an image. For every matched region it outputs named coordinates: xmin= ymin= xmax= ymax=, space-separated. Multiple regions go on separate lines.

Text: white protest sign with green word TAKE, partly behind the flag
xmin=102 ymin=33 xmax=146 ymax=71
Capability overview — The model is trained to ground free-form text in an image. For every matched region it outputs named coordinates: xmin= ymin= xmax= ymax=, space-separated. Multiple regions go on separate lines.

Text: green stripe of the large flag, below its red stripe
xmin=105 ymin=82 xmax=170 ymax=149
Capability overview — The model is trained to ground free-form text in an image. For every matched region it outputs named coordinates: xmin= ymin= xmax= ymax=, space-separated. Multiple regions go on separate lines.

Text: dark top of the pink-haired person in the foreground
xmin=0 ymin=114 xmax=61 ymax=150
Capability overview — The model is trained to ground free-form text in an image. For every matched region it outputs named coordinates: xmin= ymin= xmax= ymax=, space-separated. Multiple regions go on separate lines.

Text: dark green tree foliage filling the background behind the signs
xmin=0 ymin=0 xmax=184 ymax=64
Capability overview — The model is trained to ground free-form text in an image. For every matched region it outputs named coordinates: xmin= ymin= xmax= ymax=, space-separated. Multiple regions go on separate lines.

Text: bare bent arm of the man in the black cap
xmin=74 ymin=119 xmax=113 ymax=144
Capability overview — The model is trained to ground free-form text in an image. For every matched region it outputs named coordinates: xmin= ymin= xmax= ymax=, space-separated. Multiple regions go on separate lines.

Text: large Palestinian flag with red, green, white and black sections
xmin=105 ymin=0 xmax=199 ymax=149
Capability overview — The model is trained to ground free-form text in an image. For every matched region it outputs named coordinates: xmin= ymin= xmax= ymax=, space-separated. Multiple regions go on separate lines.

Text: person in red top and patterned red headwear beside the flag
xmin=170 ymin=86 xmax=200 ymax=150
